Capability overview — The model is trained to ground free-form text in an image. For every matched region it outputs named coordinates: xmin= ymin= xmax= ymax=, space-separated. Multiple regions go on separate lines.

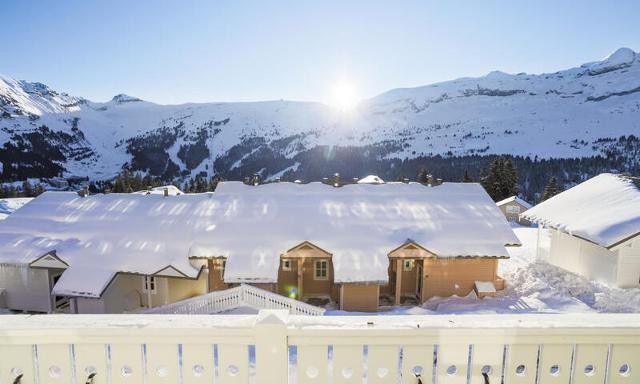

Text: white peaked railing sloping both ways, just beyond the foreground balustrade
xmin=145 ymin=284 xmax=325 ymax=316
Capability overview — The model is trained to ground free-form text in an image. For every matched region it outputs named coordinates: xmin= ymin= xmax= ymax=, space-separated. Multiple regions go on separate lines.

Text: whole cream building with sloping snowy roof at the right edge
xmin=524 ymin=173 xmax=640 ymax=288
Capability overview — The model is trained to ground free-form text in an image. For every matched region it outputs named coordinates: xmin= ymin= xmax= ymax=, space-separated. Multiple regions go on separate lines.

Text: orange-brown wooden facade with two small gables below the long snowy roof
xmin=194 ymin=241 xmax=504 ymax=312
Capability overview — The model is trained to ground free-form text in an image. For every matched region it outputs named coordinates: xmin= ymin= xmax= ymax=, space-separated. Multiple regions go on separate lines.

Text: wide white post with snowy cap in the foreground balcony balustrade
xmin=254 ymin=309 xmax=289 ymax=383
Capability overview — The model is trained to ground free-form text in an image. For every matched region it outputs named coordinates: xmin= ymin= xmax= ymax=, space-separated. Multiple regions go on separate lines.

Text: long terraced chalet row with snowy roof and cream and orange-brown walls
xmin=0 ymin=178 xmax=520 ymax=313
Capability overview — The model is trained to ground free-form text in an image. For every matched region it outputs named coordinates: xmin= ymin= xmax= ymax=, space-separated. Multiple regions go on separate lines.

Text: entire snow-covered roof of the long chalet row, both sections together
xmin=0 ymin=182 xmax=519 ymax=296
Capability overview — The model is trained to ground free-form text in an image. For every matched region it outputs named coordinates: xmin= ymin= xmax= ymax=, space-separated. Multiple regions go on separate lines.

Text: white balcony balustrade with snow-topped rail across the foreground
xmin=0 ymin=311 xmax=640 ymax=384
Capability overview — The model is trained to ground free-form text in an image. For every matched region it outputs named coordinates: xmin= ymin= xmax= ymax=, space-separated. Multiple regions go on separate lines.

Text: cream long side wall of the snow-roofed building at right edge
xmin=547 ymin=230 xmax=618 ymax=286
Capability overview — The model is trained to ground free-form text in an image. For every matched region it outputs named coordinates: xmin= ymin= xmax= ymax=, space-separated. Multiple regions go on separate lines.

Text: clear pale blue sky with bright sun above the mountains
xmin=0 ymin=0 xmax=640 ymax=104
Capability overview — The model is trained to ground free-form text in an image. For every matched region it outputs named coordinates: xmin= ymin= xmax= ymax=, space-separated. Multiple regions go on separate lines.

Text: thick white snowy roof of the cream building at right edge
xmin=522 ymin=173 xmax=640 ymax=248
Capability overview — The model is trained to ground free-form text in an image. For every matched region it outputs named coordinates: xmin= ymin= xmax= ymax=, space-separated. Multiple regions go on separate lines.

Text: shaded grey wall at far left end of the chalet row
xmin=0 ymin=264 xmax=51 ymax=313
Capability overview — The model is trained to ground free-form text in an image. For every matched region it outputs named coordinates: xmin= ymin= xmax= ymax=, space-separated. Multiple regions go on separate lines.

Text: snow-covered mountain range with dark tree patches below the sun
xmin=0 ymin=48 xmax=640 ymax=185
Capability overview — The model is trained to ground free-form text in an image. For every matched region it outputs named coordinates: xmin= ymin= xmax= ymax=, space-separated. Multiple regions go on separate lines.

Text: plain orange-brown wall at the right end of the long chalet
xmin=422 ymin=258 xmax=498 ymax=301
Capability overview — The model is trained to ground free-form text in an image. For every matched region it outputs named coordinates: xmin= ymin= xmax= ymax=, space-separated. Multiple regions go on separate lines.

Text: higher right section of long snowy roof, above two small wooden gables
xmin=186 ymin=182 xmax=519 ymax=282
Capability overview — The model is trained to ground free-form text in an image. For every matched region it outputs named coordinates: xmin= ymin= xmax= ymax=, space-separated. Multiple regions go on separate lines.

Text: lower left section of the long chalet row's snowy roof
xmin=0 ymin=192 xmax=205 ymax=297
